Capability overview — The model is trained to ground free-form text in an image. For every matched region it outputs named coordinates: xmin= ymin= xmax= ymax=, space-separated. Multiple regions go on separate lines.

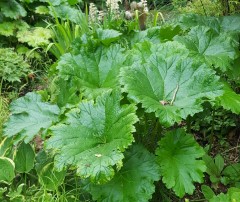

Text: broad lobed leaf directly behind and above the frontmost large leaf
xmin=57 ymin=45 xmax=125 ymax=98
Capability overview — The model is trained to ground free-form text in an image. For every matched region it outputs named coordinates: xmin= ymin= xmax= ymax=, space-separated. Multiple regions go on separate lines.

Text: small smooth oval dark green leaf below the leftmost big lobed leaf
xmin=14 ymin=142 xmax=35 ymax=173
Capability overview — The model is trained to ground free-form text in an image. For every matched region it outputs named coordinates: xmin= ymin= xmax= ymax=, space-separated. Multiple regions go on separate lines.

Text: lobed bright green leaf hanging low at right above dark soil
xmin=156 ymin=129 xmax=206 ymax=197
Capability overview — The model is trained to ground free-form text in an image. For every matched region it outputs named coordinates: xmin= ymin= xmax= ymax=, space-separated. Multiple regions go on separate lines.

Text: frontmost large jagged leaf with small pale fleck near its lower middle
xmin=47 ymin=92 xmax=138 ymax=183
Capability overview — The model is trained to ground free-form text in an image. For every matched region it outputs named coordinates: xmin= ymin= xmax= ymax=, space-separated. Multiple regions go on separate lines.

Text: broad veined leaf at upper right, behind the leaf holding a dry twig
xmin=175 ymin=26 xmax=238 ymax=71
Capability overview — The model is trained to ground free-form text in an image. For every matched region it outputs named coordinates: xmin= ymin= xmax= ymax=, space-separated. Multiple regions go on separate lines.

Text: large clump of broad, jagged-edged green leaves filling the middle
xmin=4 ymin=13 xmax=238 ymax=202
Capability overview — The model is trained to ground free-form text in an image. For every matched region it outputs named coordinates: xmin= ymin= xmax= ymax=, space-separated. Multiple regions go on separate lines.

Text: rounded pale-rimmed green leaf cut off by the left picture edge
xmin=0 ymin=157 xmax=15 ymax=182
